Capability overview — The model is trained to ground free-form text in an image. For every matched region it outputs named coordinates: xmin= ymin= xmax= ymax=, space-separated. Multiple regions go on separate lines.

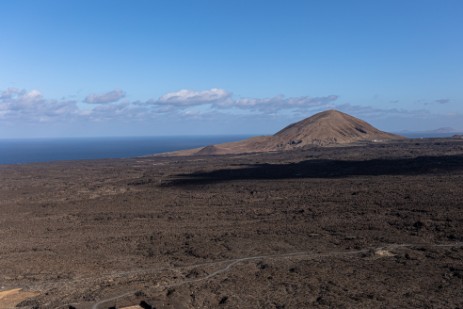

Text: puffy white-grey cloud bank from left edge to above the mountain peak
xmin=0 ymin=88 xmax=338 ymax=122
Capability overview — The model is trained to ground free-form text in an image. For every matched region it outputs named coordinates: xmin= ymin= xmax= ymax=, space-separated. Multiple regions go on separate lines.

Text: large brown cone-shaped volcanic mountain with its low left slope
xmin=163 ymin=110 xmax=404 ymax=156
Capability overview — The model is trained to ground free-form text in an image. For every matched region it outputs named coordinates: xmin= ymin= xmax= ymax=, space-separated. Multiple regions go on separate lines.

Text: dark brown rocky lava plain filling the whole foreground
xmin=0 ymin=139 xmax=463 ymax=309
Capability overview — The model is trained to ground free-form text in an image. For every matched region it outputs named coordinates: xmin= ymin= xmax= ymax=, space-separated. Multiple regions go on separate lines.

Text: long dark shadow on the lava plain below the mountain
xmin=169 ymin=155 xmax=463 ymax=185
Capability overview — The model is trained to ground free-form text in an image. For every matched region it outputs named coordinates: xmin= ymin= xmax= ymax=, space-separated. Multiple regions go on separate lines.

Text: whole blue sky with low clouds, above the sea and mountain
xmin=0 ymin=0 xmax=463 ymax=138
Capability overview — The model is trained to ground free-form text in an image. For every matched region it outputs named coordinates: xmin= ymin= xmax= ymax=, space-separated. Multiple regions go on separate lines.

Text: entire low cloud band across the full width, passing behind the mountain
xmin=0 ymin=88 xmax=463 ymax=135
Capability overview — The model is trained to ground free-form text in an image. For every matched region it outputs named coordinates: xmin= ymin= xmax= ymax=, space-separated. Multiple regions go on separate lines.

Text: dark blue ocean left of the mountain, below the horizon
xmin=0 ymin=135 xmax=250 ymax=164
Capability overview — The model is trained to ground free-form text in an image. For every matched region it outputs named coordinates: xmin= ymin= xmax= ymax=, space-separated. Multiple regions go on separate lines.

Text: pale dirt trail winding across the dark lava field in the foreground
xmin=92 ymin=242 xmax=463 ymax=309
